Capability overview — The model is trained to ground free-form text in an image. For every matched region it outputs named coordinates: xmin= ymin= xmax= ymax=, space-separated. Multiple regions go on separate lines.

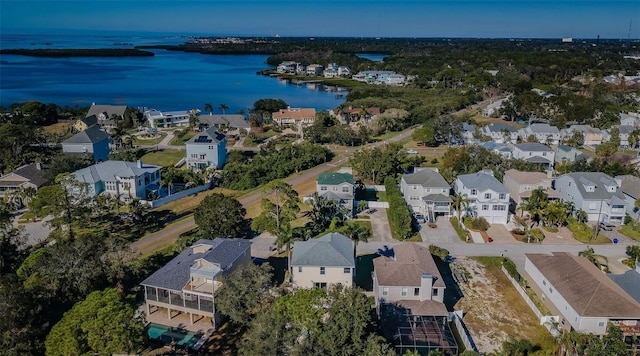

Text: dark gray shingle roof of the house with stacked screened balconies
xmin=140 ymin=238 xmax=251 ymax=291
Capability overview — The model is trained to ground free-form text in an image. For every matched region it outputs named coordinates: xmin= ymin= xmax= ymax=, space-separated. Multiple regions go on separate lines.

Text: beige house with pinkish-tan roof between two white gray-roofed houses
xmin=502 ymin=169 xmax=560 ymax=208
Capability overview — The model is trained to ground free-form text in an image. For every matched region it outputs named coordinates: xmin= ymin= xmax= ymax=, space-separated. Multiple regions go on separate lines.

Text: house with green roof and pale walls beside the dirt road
xmin=316 ymin=172 xmax=356 ymax=214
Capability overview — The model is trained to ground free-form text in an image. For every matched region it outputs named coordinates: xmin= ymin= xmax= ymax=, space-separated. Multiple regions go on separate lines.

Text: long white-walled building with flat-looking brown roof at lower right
xmin=525 ymin=252 xmax=640 ymax=335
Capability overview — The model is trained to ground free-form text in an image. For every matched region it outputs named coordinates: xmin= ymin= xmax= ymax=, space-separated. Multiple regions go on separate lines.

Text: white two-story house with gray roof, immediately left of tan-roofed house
xmin=453 ymin=170 xmax=511 ymax=225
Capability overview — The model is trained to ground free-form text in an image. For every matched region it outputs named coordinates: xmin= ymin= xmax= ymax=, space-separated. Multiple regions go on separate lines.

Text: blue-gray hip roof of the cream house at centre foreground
xmin=291 ymin=232 xmax=356 ymax=267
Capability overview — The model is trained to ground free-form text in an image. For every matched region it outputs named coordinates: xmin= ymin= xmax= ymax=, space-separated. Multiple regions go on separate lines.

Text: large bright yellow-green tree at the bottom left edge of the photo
xmin=45 ymin=288 xmax=144 ymax=356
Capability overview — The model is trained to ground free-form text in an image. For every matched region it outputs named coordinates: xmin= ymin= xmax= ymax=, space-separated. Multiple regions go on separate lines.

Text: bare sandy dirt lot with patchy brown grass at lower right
xmin=452 ymin=257 xmax=553 ymax=353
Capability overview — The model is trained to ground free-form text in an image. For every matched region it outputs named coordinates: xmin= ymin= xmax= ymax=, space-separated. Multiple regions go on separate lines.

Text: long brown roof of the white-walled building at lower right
xmin=525 ymin=252 xmax=640 ymax=318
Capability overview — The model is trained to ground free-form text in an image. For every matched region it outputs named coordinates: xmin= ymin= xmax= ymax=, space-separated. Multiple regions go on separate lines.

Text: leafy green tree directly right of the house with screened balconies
xmin=216 ymin=263 xmax=273 ymax=325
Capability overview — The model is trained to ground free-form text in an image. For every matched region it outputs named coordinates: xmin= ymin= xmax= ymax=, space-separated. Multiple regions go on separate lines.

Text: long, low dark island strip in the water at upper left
xmin=0 ymin=48 xmax=154 ymax=57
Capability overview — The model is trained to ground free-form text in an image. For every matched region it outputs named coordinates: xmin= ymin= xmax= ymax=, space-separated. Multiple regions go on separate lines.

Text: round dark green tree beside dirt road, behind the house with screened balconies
xmin=193 ymin=193 xmax=247 ymax=239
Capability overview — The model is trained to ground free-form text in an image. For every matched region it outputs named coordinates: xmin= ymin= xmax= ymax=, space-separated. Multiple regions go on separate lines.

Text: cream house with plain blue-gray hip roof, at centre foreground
xmin=291 ymin=232 xmax=356 ymax=288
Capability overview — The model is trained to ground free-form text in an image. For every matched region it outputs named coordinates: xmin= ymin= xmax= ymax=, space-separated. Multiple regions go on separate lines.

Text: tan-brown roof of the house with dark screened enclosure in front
xmin=373 ymin=242 xmax=445 ymax=287
